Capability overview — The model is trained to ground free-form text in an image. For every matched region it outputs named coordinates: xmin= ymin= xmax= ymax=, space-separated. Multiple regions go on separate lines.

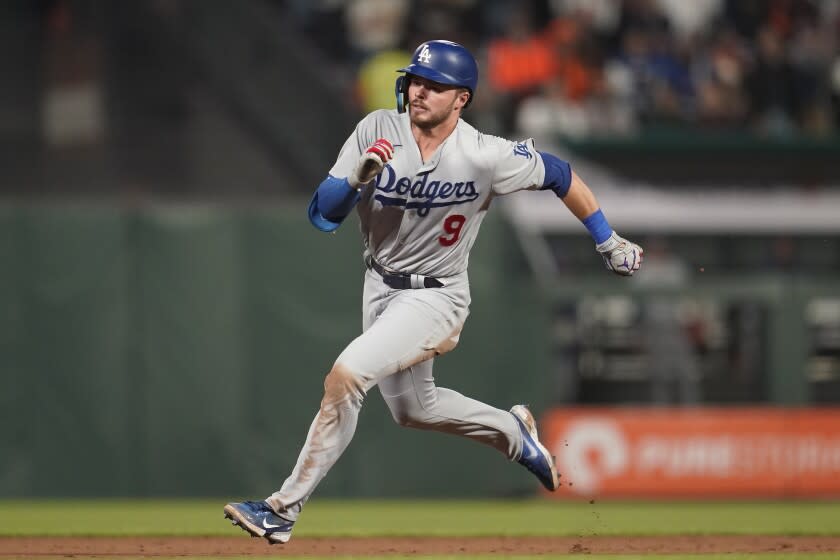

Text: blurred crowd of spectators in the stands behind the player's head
xmin=300 ymin=0 xmax=840 ymax=142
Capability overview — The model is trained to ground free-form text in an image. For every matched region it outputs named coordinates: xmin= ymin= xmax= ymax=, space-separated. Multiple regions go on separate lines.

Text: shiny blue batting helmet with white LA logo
xmin=396 ymin=40 xmax=478 ymax=113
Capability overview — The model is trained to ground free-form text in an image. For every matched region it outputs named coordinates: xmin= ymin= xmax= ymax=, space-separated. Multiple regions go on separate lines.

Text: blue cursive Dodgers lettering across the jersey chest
xmin=375 ymin=165 xmax=478 ymax=217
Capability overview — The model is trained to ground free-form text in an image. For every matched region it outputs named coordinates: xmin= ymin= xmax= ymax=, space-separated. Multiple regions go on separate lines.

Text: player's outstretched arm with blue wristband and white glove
xmin=538 ymin=152 xmax=644 ymax=276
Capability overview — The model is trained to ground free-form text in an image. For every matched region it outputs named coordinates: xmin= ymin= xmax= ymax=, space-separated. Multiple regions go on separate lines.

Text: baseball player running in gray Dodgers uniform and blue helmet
xmin=224 ymin=41 xmax=642 ymax=543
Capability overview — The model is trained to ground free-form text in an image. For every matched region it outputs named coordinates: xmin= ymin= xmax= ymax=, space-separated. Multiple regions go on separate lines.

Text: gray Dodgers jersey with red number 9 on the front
xmin=330 ymin=110 xmax=545 ymax=278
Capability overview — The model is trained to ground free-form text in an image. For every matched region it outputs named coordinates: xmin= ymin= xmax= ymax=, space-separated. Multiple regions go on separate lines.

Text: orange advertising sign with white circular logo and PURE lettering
xmin=540 ymin=408 xmax=840 ymax=497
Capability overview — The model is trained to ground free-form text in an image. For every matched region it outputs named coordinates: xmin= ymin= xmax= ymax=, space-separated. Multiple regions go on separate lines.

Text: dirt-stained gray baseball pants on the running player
xmin=266 ymin=270 xmax=522 ymax=521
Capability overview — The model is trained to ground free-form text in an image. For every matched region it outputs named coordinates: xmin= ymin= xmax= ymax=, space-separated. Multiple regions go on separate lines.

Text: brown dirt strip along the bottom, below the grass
xmin=0 ymin=536 xmax=840 ymax=558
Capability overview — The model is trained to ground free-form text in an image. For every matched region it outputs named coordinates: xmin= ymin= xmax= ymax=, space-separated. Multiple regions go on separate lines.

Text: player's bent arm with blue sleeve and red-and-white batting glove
xmin=309 ymin=138 xmax=394 ymax=232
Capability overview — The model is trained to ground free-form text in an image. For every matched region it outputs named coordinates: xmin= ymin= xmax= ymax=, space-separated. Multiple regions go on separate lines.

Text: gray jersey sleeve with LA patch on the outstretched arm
xmin=489 ymin=137 xmax=545 ymax=195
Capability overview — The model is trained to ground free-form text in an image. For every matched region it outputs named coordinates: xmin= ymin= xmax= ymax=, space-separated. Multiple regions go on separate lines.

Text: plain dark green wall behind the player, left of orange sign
xmin=0 ymin=201 xmax=548 ymax=497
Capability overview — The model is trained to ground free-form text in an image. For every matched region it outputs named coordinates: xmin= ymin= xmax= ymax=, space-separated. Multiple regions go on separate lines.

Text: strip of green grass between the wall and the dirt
xmin=0 ymin=498 xmax=840 ymax=540
